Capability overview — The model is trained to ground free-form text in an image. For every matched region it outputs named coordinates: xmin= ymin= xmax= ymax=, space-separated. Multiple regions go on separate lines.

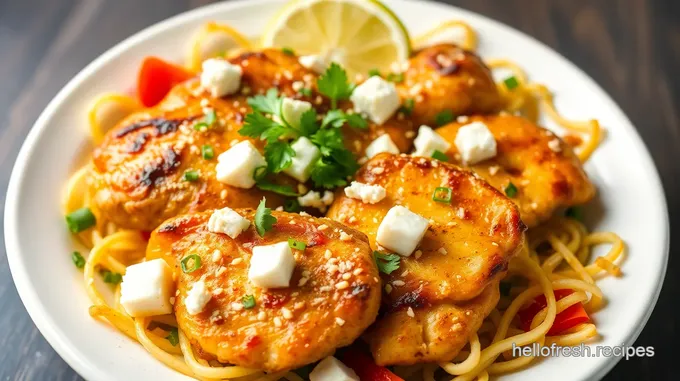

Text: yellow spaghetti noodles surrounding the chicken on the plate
xmin=64 ymin=21 xmax=624 ymax=381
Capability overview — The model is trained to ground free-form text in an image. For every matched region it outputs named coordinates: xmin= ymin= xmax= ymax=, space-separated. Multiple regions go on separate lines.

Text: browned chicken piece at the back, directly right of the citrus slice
xmin=397 ymin=44 xmax=502 ymax=126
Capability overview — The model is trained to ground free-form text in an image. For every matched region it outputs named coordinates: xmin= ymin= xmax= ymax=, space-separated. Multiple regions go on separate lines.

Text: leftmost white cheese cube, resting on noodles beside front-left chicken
xmin=120 ymin=259 xmax=175 ymax=317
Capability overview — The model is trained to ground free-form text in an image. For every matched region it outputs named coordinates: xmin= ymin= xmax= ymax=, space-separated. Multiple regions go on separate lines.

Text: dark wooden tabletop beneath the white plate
xmin=0 ymin=0 xmax=680 ymax=380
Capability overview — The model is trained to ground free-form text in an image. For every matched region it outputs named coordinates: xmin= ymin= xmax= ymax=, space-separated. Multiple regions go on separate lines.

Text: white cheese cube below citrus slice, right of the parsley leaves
xmin=350 ymin=76 xmax=400 ymax=124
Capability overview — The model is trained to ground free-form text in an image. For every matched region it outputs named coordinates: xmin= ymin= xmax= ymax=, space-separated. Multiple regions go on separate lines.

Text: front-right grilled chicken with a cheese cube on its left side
xmin=328 ymin=154 xmax=525 ymax=365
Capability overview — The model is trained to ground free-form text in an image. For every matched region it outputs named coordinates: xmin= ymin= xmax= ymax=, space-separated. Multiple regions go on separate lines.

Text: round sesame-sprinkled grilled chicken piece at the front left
xmin=147 ymin=209 xmax=380 ymax=372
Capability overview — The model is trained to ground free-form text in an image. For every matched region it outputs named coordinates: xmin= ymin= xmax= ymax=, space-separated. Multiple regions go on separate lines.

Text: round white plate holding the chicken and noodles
xmin=5 ymin=0 xmax=669 ymax=380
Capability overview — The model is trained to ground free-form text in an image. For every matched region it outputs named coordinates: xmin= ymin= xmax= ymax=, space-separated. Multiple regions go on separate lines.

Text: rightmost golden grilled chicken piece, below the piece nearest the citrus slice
xmin=437 ymin=115 xmax=595 ymax=227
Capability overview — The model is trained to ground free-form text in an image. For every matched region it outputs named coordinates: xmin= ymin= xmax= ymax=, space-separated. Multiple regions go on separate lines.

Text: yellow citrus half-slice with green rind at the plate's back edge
xmin=262 ymin=0 xmax=411 ymax=74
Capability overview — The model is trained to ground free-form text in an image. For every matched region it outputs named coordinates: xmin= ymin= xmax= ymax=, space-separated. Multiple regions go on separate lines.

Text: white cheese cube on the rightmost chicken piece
xmin=454 ymin=122 xmax=496 ymax=164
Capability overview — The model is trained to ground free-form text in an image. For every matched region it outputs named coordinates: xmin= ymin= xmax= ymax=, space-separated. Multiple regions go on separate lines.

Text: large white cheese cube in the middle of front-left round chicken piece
xmin=248 ymin=242 xmax=295 ymax=288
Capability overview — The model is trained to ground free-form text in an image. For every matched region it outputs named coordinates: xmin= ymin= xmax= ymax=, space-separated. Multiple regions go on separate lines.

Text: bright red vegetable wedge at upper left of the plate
xmin=137 ymin=57 xmax=194 ymax=107
